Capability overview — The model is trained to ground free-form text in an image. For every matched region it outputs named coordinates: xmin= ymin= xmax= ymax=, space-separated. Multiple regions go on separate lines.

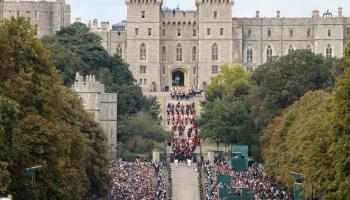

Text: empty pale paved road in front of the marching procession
xmin=172 ymin=164 xmax=199 ymax=200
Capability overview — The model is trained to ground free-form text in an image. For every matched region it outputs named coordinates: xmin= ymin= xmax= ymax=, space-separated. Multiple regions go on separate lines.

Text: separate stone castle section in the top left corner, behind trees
xmin=0 ymin=0 xmax=71 ymax=37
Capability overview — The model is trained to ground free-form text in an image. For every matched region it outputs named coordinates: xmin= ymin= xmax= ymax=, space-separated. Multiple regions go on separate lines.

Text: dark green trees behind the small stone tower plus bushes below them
xmin=41 ymin=23 xmax=163 ymax=153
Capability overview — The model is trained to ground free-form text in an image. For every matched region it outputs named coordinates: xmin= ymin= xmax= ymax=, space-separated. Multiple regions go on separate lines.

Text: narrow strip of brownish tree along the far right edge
xmin=328 ymin=39 xmax=350 ymax=199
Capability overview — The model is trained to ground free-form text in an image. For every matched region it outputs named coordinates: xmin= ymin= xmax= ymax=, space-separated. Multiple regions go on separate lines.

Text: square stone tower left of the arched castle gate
xmin=125 ymin=0 xmax=163 ymax=92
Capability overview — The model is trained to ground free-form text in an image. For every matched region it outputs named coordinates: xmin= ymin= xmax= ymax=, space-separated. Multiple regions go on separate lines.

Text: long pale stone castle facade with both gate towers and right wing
xmin=90 ymin=0 xmax=350 ymax=92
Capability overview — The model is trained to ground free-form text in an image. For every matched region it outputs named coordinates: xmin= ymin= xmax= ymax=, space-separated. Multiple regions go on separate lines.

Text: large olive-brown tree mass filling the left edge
xmin=0 ymin=18 xmax=109 ymax=199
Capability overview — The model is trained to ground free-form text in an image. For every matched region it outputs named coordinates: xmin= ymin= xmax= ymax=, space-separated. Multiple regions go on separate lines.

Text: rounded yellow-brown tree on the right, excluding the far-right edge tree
xmin=262 ymin=91 xmax=334 ymax=193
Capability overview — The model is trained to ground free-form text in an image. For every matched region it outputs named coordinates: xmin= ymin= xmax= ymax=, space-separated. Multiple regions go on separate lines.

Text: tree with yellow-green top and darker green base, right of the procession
xmin=199 ymin=65 xmax=257 ymax=152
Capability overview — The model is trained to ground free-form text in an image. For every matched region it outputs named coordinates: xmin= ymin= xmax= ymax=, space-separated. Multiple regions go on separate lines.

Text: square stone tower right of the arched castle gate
xmin=196 ymin=0 xmax=234 ymax=88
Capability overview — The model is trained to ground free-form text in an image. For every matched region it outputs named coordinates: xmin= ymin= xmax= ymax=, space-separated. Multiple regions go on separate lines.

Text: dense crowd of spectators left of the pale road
xmin=108 ymin=160 xmax=160 ymax=200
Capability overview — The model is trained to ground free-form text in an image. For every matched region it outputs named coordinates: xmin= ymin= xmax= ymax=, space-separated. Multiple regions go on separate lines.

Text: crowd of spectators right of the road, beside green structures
xmin=213 ymin=162 xmax=293 ymax=200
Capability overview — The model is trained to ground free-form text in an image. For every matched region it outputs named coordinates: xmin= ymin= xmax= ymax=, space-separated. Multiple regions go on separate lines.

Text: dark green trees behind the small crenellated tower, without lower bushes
xmin=41 ymin=23 xmax=159 ymax=120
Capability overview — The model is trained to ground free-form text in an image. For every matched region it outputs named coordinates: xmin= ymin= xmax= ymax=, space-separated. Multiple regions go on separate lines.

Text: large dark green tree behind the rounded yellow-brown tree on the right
xmin=251 ymin=50 xmax=341 ymax=130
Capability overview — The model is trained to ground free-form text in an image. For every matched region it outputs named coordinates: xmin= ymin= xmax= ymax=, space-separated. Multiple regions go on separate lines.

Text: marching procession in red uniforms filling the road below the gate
xmin=166 ymin=102 xmax=200 ymax=166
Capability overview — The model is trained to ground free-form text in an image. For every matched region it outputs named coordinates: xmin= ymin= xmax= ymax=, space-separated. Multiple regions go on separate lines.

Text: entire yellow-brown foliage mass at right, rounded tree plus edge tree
xmin=262 ymin=45 xmax=350 ymax=200
